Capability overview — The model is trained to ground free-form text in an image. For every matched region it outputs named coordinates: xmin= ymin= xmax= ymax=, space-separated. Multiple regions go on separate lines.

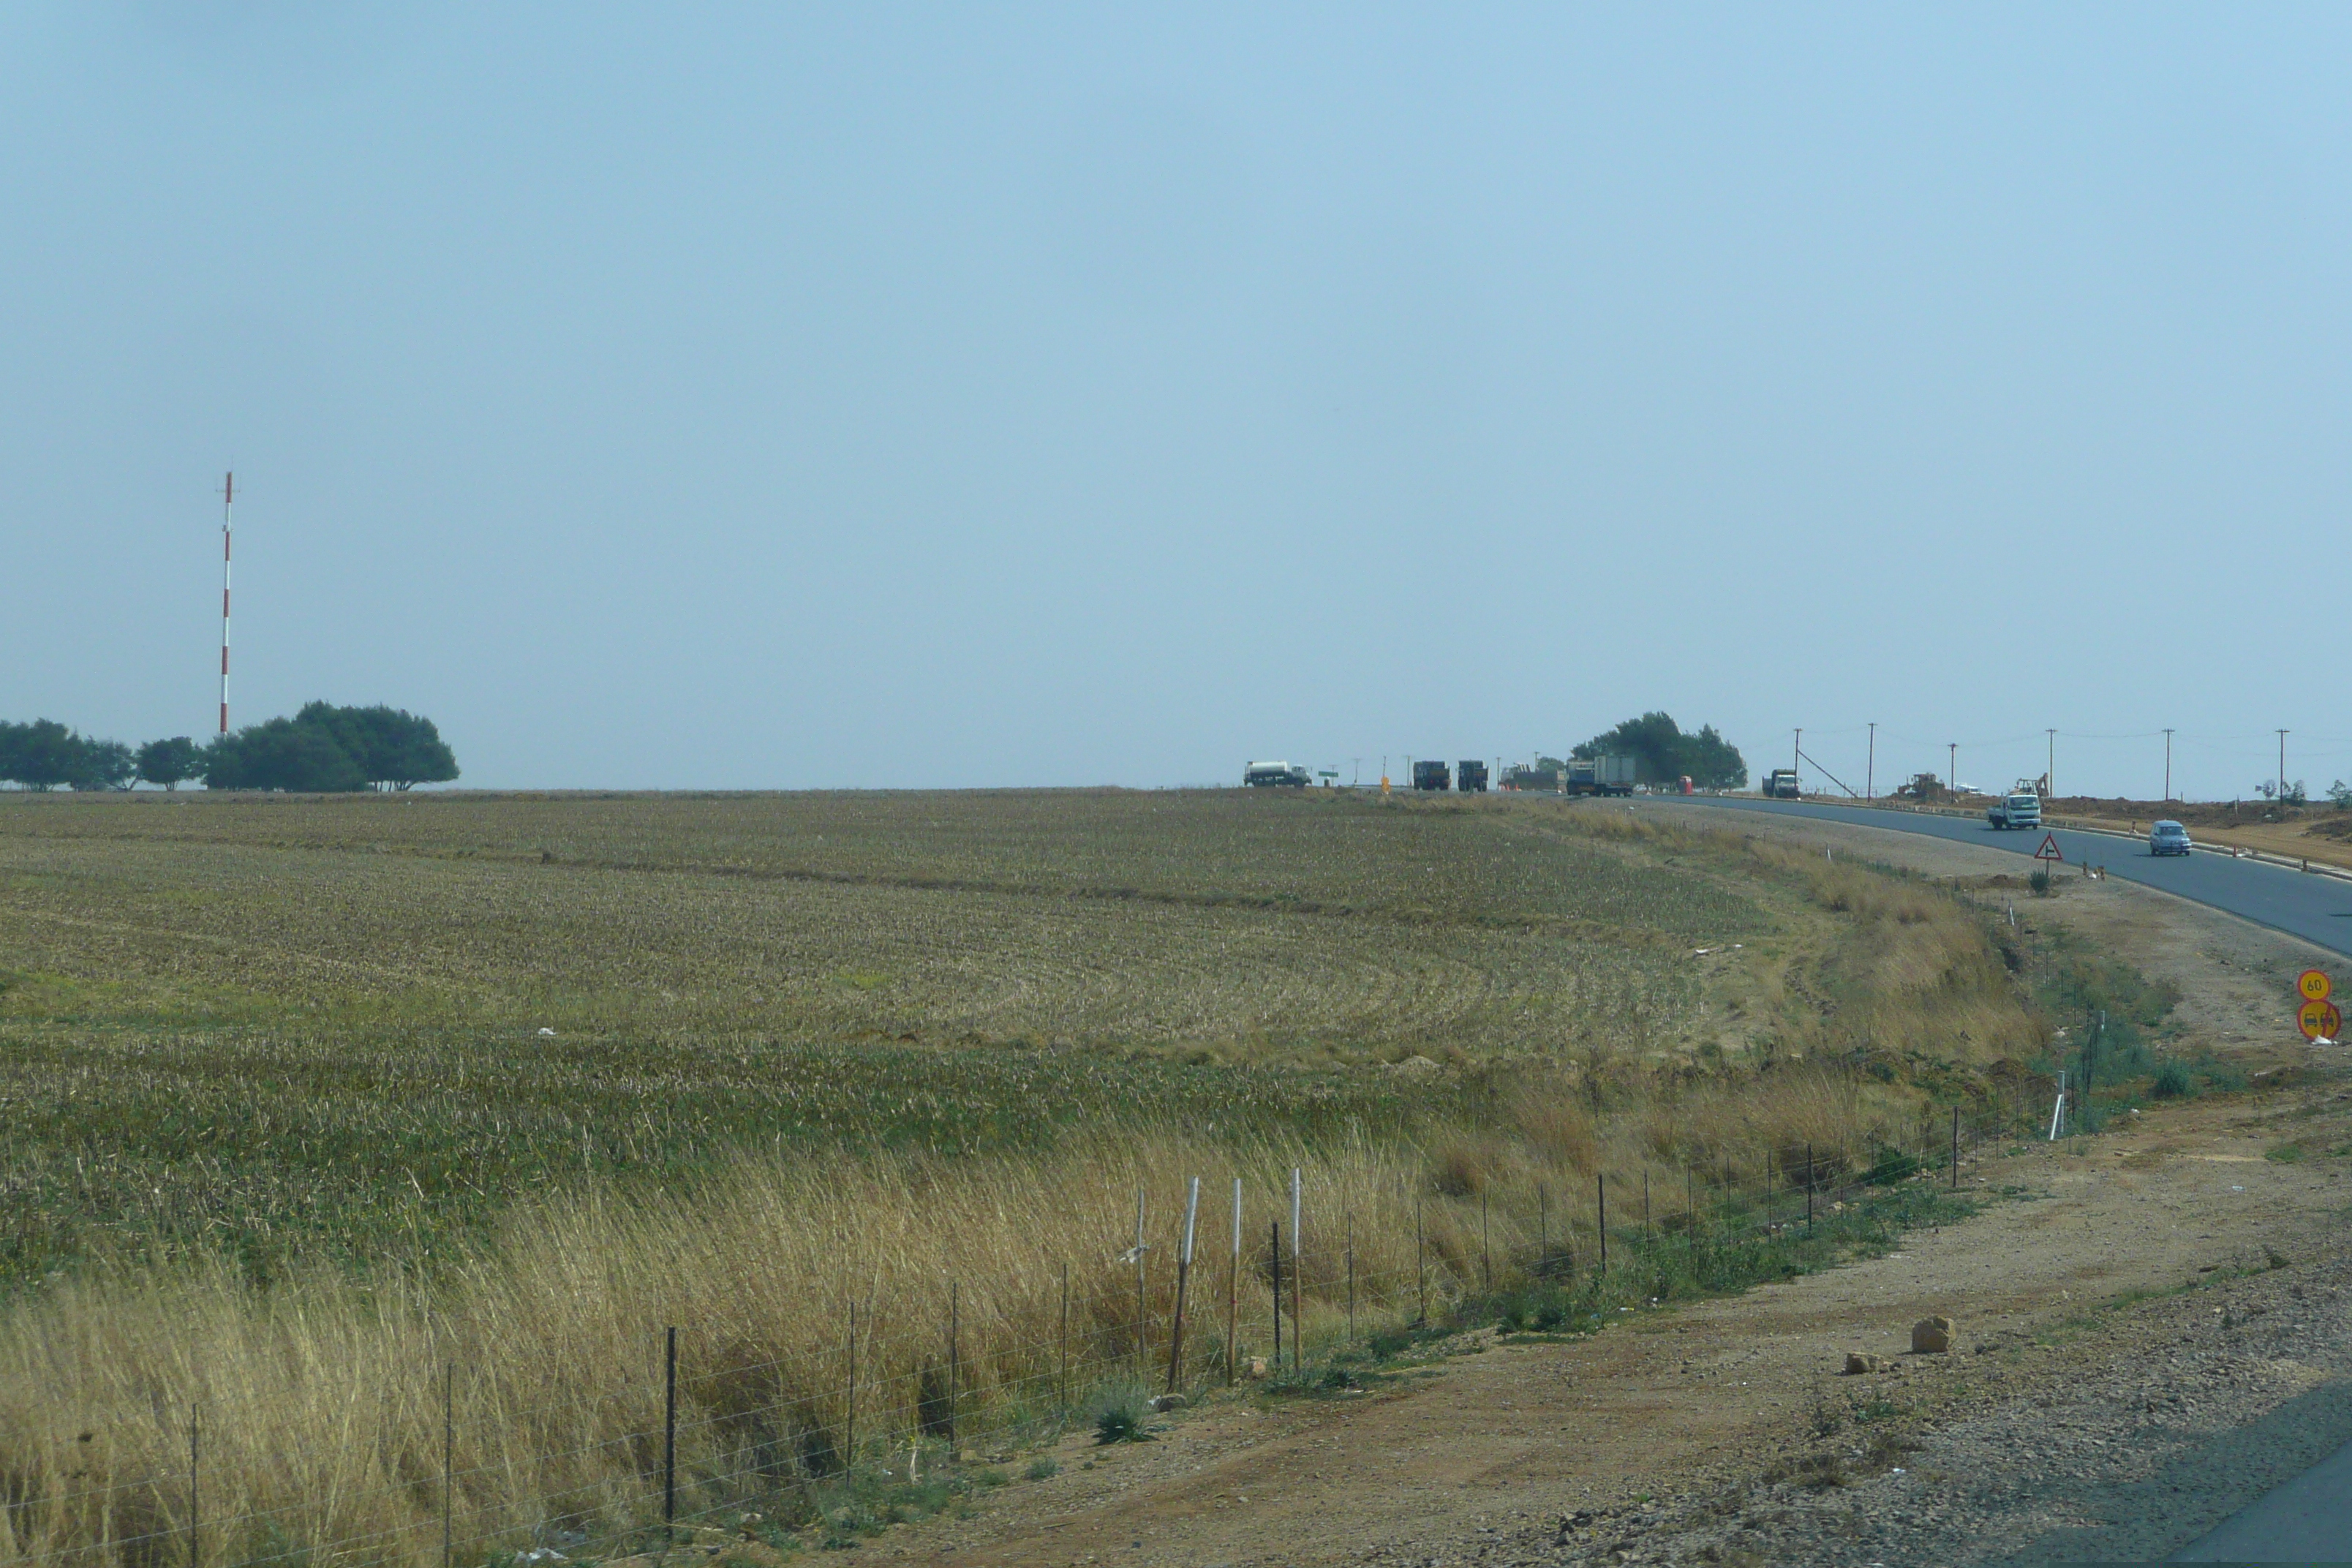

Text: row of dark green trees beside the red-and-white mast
xmin=0 ymin=703 xmax=456 ymax=792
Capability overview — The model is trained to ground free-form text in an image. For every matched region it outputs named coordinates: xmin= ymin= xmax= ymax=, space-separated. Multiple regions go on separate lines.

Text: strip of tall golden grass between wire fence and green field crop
xmin=0 ymin=1070 xmax=1975 ymax=1568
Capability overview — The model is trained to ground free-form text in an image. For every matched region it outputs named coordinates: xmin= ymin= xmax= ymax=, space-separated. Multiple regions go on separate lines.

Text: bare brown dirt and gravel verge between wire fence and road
xmin=840 ymin=823 xmax=2352 ymax=1566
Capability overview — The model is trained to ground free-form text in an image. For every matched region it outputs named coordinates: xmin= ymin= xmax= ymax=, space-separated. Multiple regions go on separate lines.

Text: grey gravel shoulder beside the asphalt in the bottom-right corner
xmin=1420 ymin=1248 xmax=2352 ymax=1568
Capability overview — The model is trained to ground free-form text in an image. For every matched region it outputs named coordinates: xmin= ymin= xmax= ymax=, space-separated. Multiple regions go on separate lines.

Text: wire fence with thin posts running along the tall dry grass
xmin=0 ymin=1074 xmax=2062 ymax=1568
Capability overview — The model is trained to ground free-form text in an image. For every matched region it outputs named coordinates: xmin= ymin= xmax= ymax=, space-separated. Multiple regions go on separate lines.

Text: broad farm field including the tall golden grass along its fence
xmin=0 ymin=790 xmax=2081 ymax=1564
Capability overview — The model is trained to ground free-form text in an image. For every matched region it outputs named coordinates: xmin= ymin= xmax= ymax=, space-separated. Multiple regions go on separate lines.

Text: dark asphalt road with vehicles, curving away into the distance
xmin=1675 ymin=794 xmax=2352 ymax=954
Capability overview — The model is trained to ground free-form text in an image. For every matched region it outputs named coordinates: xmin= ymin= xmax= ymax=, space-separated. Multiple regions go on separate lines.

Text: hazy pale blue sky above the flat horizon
xmin=0 ymin=0 xmax=2352 ymax=794
